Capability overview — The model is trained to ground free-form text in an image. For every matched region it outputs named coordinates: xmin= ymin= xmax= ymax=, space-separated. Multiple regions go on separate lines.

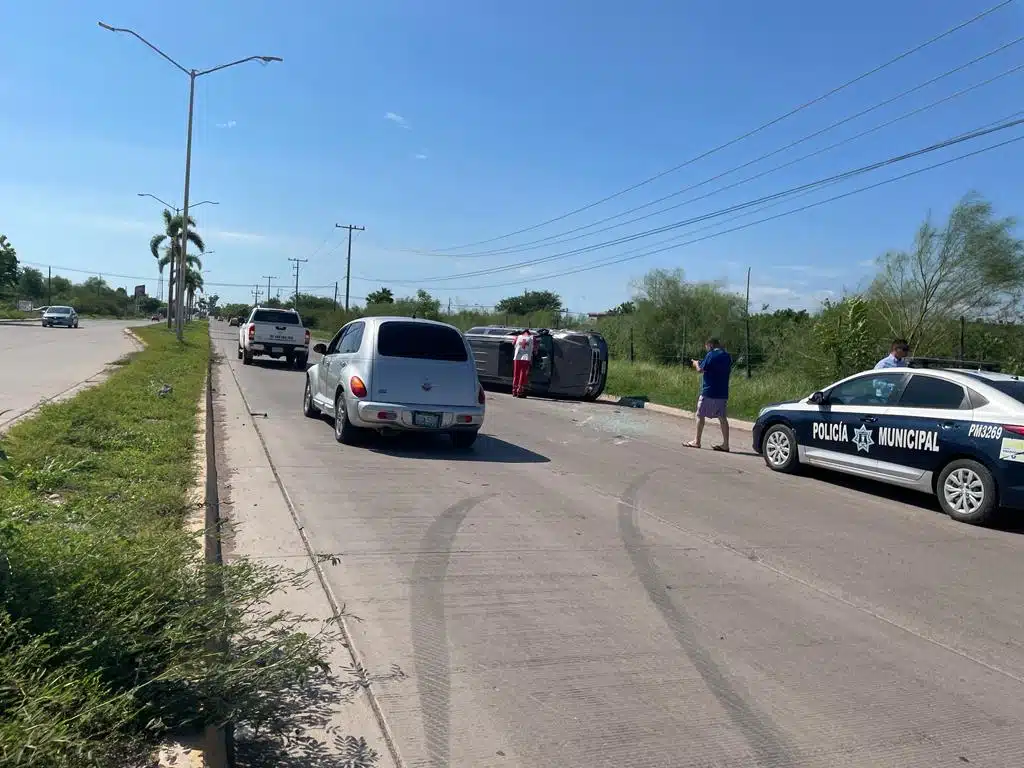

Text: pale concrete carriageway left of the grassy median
xmin=0 ymin=318 xmax=148 ymax=428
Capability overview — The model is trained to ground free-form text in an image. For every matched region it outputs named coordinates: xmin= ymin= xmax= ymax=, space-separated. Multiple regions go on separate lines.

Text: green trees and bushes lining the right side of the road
xmin=221 ymin=195 xmax=1024 ymax=380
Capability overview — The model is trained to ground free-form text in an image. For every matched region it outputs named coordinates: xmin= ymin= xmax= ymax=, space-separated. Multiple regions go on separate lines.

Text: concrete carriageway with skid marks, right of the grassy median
xmin=213 ymin=325 xmax=1024 ymax=768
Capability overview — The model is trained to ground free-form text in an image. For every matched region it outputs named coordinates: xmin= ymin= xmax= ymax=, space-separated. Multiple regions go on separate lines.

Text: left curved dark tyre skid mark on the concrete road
xmin=410 ymin=494 xmax=494 ymax=768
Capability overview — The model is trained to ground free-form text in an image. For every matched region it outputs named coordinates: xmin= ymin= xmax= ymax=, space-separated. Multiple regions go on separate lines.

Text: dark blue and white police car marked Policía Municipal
xmin=754 ymin=358 xmax=1024 ymax=523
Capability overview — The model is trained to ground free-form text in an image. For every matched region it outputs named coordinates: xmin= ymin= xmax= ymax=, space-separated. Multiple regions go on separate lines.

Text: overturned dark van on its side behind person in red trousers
xmin=466 ymin=326 xmax=608 ymax=400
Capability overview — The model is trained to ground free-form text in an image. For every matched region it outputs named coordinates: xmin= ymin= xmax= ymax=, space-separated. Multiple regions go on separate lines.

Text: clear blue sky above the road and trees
xmin=0 ymin=0 xmax=1024 ymax=311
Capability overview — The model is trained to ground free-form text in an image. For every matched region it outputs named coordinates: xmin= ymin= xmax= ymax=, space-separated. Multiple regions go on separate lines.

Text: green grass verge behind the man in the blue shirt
xmin=605 ymin=360 xmax=820 ymax=419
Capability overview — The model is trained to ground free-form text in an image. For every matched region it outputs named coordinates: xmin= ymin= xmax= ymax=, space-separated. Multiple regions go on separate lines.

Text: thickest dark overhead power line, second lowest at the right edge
xmin=360 ymin=119 xmax=1024 ymax=285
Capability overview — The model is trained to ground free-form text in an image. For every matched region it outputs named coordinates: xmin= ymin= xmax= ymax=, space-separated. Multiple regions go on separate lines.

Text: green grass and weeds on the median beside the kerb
xmin=0 ymin=323 xmax=350 ymax=768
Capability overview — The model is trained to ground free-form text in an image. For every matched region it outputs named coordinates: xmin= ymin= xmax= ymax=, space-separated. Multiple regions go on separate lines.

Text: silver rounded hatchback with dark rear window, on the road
xmin=302 ymin=317 xmax=485 ymax=449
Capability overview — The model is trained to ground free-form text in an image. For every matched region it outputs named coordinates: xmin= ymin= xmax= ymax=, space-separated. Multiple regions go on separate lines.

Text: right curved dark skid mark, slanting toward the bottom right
xmin=618 ymin=469 xmax=797 ymax=768
